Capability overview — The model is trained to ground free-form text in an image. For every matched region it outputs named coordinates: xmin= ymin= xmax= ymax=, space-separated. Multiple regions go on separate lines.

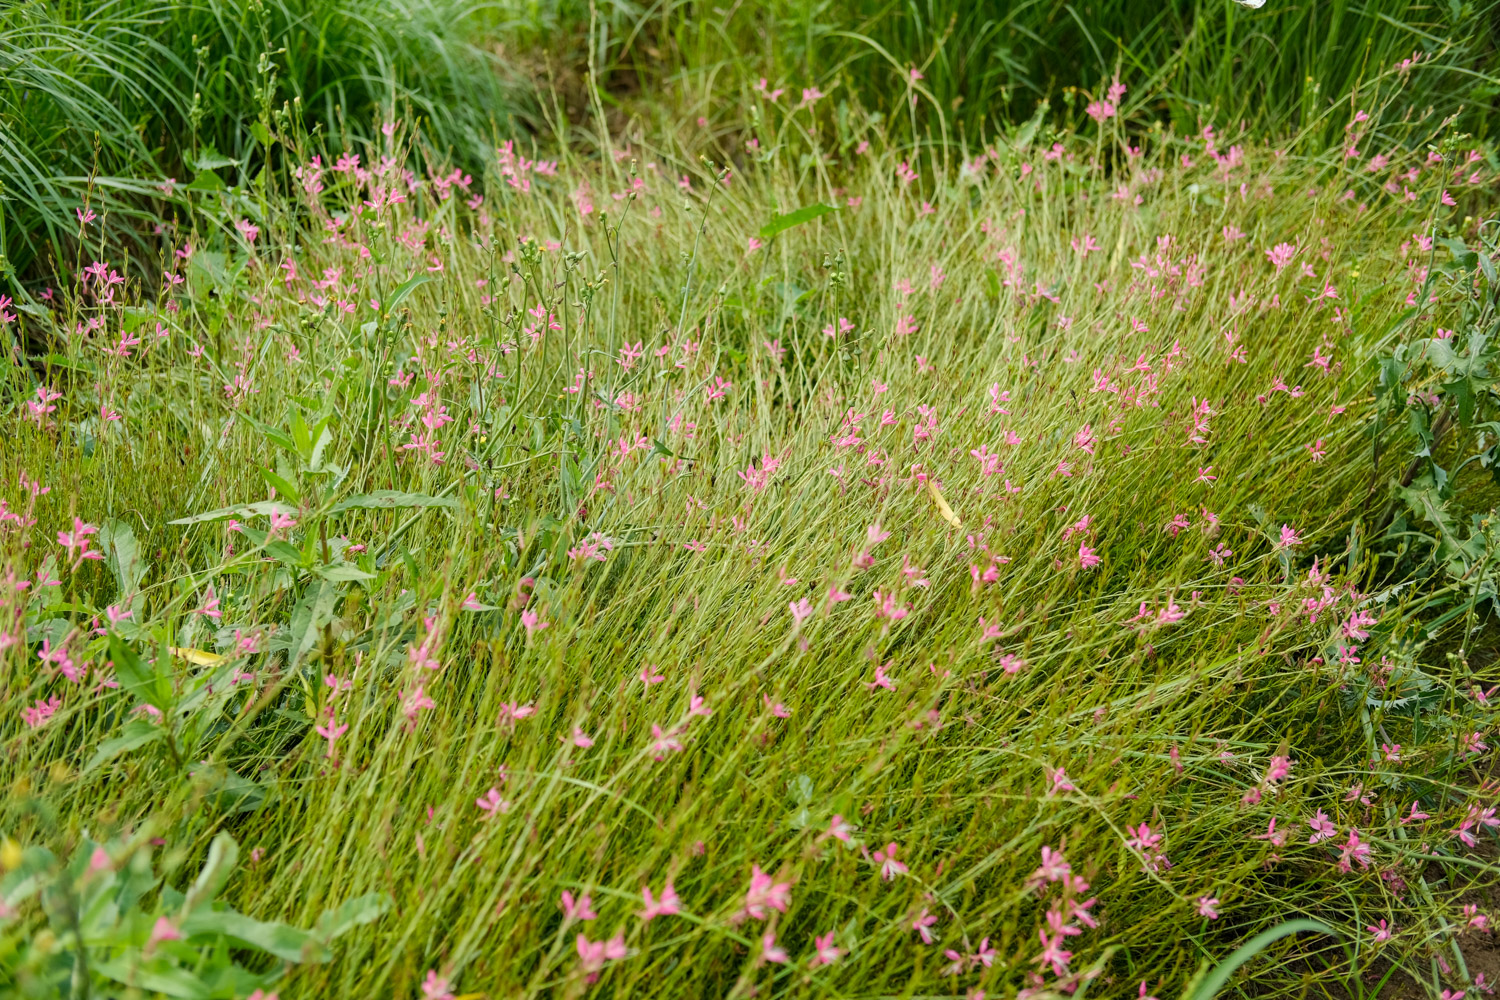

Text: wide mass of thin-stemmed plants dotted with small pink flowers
xmin=0 ymin=3 xmax=1500 ymax=1000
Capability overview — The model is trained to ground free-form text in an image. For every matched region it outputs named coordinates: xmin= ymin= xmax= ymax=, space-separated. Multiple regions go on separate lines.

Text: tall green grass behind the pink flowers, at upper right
xmin=591 ymin=0 xmax=1500 ymax=142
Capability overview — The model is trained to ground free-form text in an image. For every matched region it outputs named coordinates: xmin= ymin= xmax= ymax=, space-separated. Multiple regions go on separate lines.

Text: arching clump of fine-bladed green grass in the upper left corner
xmin=0 ymin=0 xmax=534 ymax=283
